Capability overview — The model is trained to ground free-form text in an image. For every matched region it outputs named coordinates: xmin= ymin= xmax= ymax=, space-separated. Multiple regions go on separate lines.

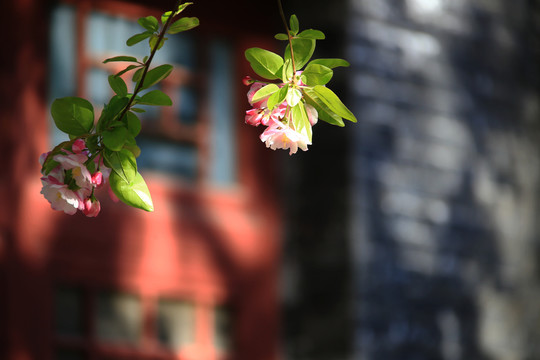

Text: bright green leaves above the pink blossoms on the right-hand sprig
xmin=245 ymin=15 xmax=356 ymax=129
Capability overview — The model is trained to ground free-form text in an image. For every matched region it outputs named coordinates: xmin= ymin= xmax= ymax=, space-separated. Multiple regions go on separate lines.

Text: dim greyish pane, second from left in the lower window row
xmin=95 ymin=292 xmax=142 ymax=344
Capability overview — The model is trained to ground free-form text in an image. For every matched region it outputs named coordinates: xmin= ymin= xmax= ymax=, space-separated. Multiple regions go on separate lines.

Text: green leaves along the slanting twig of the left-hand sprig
xmin=42 ymin=2 xmax=199 ymax=211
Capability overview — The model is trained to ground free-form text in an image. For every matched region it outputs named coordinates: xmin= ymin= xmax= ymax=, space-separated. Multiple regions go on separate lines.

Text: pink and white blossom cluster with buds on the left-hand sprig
xmin=39 ymin=139 xmax=111 ymax=217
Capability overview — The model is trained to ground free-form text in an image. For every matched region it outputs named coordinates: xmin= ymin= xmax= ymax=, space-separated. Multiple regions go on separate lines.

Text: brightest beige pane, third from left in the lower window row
xmin=157 ymin=300 xmax=195 ymax=350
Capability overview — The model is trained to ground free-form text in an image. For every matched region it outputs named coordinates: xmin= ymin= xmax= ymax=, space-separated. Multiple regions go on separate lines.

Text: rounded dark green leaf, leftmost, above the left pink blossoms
xmin=51 ymin=96 xmax=94 ymax=136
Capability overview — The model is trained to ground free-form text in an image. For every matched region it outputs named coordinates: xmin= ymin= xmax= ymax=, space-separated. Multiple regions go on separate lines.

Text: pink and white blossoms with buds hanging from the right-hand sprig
xmin=244 ymin=76 xmax=318 ymax=155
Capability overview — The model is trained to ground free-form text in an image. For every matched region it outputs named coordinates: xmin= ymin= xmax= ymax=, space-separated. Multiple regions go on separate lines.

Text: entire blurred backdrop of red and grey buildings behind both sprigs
xmin=0 ymin=0 xmax=540 ymax=360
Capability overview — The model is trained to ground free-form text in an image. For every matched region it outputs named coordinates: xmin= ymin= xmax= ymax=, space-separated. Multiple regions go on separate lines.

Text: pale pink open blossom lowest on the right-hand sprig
xmin=260 ymin=121 xmax=311 ymax=155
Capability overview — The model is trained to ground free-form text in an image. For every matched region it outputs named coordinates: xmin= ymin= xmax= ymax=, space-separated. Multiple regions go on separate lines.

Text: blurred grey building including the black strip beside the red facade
xmin=283 ymin=0 xmax=540 ymax=360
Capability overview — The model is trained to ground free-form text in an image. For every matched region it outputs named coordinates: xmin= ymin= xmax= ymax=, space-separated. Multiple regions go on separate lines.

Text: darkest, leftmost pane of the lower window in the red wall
xmin=54 ymin=288 xmax=83 ymax=336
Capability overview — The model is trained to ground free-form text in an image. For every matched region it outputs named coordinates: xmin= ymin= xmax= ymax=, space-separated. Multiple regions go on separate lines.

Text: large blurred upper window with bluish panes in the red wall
xmin=50 ymin=1 xmax=236 ymax=186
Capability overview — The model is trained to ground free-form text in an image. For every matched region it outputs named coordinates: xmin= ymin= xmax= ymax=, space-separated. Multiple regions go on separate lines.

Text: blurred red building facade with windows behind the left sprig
xmin=0 ymin=0 xmax=280 ymax=360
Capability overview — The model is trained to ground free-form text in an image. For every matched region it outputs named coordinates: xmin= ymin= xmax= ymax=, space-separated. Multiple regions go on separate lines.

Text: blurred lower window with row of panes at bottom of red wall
xmin=53 ymin=286 xmax=231 ymax=360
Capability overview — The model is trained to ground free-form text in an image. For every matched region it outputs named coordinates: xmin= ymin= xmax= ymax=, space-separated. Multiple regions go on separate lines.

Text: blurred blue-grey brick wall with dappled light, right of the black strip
xmin=350 ymin=0 xmax=540 ymax=360
